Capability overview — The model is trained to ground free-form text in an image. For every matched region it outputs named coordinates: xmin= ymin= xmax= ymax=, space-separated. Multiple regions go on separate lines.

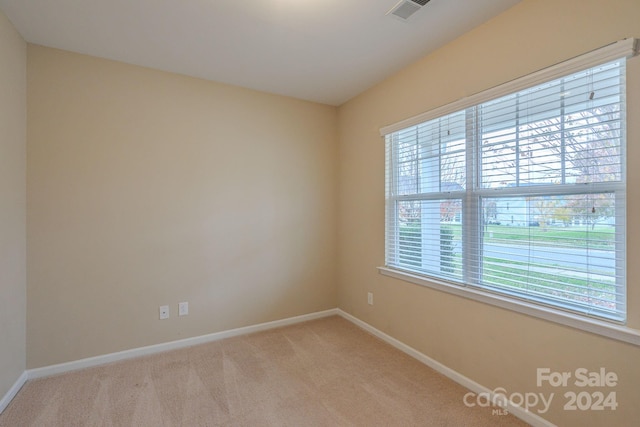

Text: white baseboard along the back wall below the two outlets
xmin=28 ymin=308 xmax=338 ymax=382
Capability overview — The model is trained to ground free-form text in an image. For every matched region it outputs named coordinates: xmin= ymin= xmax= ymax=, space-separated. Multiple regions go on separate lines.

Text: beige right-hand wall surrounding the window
xmin=339 ymin=0 xmax=640 ymax=426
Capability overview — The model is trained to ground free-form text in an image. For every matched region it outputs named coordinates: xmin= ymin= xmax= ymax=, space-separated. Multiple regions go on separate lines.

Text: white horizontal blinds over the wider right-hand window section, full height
xmin=478 ymin=61 xmax=625 ymax=320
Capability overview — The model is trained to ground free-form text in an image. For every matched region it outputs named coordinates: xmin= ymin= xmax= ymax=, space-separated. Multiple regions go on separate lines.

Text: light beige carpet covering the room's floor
xmin=0 ymin=317 xmax=526 ymax=427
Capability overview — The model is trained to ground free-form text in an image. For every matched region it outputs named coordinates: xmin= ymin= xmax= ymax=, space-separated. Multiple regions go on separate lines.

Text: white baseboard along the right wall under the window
xmin=337 ymin=309 xmax=556 ymax=427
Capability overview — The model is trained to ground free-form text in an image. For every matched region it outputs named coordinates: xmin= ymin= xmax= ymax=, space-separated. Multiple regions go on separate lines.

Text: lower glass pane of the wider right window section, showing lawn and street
xmin=481 ymin=193 xmax=622 ymax=318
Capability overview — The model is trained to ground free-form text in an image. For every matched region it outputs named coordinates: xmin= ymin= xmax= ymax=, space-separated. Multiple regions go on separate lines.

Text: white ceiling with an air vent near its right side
xmin=0 ymin=0 xmax=519 ymax=105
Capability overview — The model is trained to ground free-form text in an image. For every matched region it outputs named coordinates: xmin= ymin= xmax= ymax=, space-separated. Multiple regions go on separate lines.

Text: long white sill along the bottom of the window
xmin=378 ymin=267 xmax=640 ymax=346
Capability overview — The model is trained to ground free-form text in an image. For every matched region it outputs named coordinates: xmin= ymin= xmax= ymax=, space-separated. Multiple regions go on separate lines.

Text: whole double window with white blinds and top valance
xmin=381 ymin=40 xmax=635 ymax=323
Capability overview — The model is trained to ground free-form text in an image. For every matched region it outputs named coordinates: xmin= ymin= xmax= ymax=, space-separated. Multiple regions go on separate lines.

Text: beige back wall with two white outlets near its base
xmin=27 ymin=45 xmax=337 ymax=368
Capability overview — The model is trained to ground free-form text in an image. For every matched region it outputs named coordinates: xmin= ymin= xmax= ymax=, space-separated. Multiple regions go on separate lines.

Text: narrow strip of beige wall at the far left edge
xmin=0 ymin=12 xmax=27 ymax=398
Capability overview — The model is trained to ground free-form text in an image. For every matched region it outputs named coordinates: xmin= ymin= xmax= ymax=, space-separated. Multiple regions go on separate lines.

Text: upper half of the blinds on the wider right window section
xmin=478 ymin=61 xmax=624 ymax=188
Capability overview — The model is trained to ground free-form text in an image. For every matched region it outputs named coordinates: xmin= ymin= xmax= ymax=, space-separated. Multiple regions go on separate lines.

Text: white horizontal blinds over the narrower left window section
xmin=386 ymin=112 xmax=466 ymax=279
